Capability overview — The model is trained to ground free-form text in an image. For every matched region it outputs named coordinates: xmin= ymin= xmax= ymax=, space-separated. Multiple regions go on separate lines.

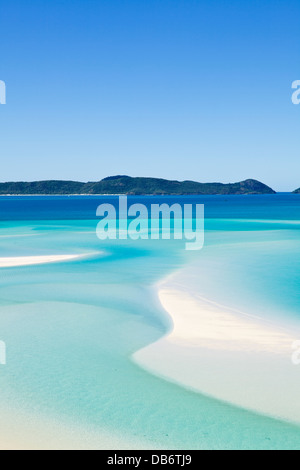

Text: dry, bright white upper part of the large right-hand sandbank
xmin=159 ymin=289 xmax=295 ymax=354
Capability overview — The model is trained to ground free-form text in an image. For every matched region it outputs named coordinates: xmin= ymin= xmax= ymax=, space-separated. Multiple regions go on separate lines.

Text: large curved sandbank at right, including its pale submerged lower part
xmin=133 ymin=281 xmax=300 ymax=424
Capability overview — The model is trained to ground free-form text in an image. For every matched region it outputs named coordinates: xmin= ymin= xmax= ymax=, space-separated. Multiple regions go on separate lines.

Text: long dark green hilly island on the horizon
xmin=0 ymin=176 xmax=276 ymax=196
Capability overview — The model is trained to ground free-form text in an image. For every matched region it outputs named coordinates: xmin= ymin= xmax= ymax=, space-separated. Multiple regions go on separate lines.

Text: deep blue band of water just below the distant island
xmin=0 ymin=193 xmax=300 ymax=221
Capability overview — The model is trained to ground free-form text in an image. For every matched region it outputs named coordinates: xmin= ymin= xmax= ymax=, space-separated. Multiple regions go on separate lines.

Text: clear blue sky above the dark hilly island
xmin=0 ymin=0 xmax=300 ymax=191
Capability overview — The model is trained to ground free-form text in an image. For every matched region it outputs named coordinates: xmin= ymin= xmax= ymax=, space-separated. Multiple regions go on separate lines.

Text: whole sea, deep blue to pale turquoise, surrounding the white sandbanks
xmin=0 ymin=195 xmax=300 ymax=449
